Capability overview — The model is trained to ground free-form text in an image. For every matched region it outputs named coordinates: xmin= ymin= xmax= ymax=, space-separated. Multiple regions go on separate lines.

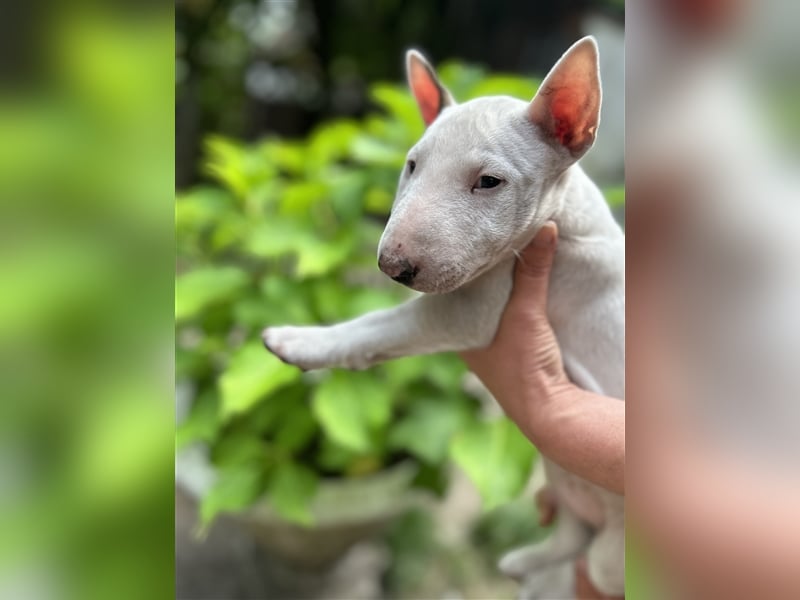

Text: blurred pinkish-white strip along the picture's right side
xmin=625 ymin=0 xmax=800 ymax=598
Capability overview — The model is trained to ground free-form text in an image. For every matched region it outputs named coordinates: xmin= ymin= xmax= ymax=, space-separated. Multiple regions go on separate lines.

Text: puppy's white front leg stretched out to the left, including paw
xmin=261 ymin=264 xmax=511 ymax=370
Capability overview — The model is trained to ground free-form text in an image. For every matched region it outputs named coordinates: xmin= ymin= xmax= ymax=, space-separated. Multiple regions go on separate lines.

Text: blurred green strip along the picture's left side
xmin=0 ymin=3 xmax=174 ymax=599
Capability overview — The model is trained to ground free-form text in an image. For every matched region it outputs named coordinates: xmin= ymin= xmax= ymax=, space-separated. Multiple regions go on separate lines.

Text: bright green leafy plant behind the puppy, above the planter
xmin=175 ymin=63 xmax=548 ymax=525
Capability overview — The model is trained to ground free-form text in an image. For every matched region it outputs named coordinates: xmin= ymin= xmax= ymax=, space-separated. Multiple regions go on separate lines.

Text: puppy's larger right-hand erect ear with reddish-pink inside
xmin=528 ymin=36 xmax=602 ymax=159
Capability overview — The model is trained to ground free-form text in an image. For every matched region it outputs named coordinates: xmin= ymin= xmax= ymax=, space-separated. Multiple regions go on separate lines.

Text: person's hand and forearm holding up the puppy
xmin=461 ymin=223 xmax=625 ymax=494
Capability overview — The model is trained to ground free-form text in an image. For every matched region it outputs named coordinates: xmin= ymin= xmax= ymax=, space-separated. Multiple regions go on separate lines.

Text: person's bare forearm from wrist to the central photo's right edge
xmin=521 ymin=383 xmax=625 ymax=495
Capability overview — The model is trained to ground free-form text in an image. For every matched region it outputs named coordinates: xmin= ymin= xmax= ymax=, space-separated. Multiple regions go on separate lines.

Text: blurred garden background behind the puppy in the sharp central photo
xmin=175 ymin=0 xmax=625 ymax=599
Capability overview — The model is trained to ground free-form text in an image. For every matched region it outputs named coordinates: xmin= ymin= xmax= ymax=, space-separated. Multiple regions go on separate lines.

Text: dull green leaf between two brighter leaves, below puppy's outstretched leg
xmin=389 ymin=398 xmax=469 ymax=465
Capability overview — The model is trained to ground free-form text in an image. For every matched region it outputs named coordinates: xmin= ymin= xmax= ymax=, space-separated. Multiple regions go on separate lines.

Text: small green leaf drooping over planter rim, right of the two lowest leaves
xmin=268 ymin=462 xmax=319 ymax=525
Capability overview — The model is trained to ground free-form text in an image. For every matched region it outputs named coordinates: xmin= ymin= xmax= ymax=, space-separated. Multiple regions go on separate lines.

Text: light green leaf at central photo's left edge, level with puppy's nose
xmin=175 ymin=266 xmax=249 ymax=321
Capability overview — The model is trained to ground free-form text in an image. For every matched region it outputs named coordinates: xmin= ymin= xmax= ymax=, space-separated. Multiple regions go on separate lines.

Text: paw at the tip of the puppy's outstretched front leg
xmin=261 ymin=326 xmax=335 ymax=371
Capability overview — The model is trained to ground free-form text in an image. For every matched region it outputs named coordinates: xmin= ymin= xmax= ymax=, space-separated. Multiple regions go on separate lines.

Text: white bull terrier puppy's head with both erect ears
xmin=378 ymin=38 xmax=600 ymax=293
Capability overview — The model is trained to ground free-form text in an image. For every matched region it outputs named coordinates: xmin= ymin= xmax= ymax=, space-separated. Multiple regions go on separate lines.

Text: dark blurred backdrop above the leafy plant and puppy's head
xmin=176 ymin=0 xmax=624 ymax=188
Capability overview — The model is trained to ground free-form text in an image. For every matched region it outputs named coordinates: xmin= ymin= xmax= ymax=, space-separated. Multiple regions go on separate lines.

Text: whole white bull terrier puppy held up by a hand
xmin=264 ymin=39 xmax=624 ymax=598
